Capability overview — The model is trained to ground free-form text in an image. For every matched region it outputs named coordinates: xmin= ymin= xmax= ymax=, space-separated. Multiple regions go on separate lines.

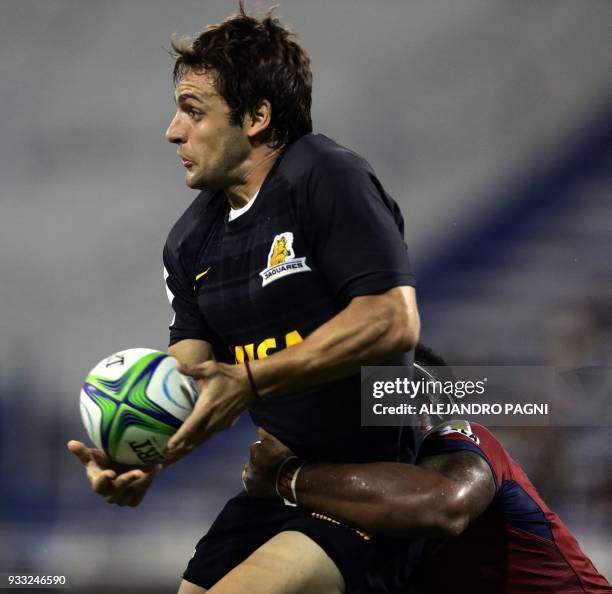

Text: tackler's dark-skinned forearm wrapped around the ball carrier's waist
xmin=279 ymin=462 xmax=463 ymax=537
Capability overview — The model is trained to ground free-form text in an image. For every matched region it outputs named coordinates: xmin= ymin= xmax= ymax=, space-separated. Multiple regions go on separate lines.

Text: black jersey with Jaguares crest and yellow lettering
xmin=164 ymin=134 xmax=413 ymax=462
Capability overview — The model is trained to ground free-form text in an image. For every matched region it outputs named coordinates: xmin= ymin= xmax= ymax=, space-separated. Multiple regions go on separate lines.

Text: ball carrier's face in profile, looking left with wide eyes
xmin=166 ymin=71 xmax=251 ymax=190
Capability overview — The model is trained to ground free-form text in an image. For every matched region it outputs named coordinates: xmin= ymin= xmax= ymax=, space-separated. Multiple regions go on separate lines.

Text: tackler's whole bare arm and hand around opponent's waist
xmin=244 ymin=434 xmax=495 ymax=537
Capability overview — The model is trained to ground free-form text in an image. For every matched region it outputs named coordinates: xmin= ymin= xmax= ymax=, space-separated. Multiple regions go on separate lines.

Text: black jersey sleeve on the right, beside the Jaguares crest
xmin=305 ymin=156 xmax=414 ymax=305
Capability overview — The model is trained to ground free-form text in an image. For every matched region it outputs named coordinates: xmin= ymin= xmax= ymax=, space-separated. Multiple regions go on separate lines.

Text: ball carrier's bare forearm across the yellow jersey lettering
xmin=251 ymin=287 xmax=420 ymax=397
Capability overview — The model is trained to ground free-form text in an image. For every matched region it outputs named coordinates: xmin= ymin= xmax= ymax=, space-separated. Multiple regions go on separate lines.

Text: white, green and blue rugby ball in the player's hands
xmin=80 ymin=348 xmax=198 ymax=466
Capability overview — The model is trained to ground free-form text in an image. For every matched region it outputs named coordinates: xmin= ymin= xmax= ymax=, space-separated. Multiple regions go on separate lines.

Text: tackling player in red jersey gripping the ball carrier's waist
xmin=243 ymin=345 xmax=612 ymax=594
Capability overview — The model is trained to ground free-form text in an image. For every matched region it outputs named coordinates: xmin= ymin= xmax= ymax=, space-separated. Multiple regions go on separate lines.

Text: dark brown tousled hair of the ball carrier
xmin=171 ymin=1 xmax=312 ymax=146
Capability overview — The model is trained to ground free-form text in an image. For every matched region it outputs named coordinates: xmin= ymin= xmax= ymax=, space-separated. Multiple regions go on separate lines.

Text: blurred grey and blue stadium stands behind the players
xmin=0 ymin=0 xmax=612 ymax=594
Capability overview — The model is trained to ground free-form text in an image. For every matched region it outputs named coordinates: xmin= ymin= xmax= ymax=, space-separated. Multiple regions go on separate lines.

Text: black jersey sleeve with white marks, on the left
xmin=163 ymin=238 xmax=214 ymax=346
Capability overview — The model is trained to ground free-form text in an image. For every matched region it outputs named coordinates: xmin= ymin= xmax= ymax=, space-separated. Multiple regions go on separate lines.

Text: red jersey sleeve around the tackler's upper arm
xmin=418 ymin=420 xmax=506 ymax=491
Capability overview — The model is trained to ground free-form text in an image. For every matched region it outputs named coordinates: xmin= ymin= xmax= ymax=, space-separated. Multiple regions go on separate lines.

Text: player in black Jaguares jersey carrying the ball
xmin=69 ymin=8 xmax=419 ymax=594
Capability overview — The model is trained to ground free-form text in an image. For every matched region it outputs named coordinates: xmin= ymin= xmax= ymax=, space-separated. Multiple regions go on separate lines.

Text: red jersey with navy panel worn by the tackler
xmin=417 ymin=421 xmax=612 ymax=594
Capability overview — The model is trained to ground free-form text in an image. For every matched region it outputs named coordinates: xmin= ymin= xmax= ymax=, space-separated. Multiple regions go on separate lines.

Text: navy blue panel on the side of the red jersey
xmin=498 ymin=481 xmax=553 ymax=542
